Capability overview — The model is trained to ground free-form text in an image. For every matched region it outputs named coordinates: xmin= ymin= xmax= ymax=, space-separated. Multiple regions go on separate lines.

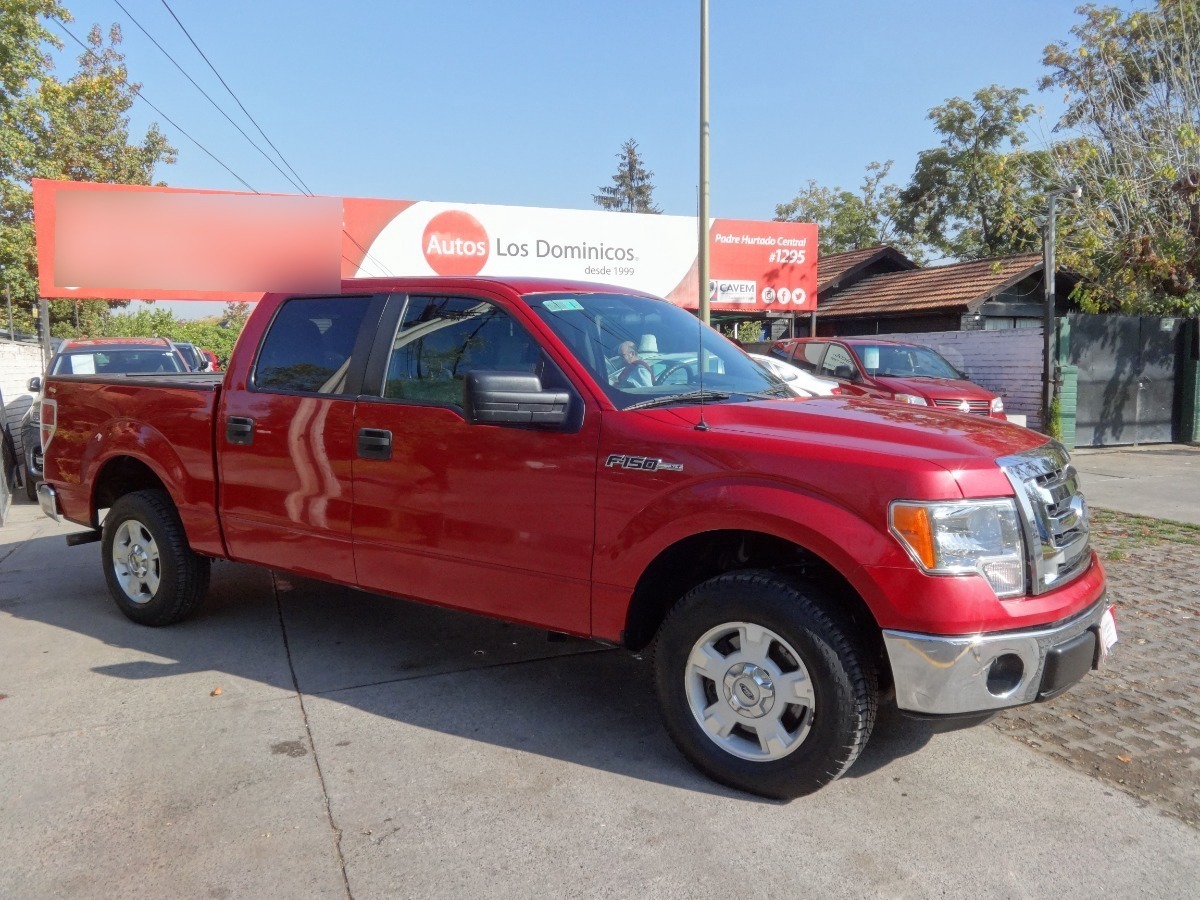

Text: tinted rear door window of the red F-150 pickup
xmin=254 ymin=296 xmax=371 ymax=394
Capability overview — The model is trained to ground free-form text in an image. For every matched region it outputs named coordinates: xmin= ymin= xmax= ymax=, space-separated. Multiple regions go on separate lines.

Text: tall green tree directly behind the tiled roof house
xmin=900 ymin=85 xmax=1046 ymax=259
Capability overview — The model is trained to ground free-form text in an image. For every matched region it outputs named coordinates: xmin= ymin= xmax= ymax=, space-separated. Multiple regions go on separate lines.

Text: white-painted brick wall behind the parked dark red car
xmin=874 ymin=328 xmax=1043 ymax=431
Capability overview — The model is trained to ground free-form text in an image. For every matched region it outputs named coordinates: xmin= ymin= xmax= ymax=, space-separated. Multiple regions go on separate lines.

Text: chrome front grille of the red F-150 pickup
xmin=996 ymin=440 xmax=1091 ymax=594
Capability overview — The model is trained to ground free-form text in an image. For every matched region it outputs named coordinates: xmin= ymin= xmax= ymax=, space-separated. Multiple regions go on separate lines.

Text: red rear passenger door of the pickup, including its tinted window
xmin=216 ymin=295 xmax=385 ymax=584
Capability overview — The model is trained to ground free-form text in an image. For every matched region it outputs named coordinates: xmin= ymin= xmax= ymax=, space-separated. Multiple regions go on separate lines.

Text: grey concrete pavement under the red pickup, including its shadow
xmin=0 ymin=504 xmax=1200 ymax=898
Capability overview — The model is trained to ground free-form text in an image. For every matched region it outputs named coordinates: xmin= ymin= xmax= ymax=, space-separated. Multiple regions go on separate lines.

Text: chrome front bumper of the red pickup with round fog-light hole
xmin=883 ymin=596 xmax=1109 ymax=715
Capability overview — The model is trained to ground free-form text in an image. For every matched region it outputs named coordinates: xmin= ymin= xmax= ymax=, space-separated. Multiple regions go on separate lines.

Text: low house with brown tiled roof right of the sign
xmin=816 ymin=247 xmax=1078 ymax=336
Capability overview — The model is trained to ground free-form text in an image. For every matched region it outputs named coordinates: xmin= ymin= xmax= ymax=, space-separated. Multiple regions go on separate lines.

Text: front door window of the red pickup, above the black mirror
xmin=383 ymin=296 xmax=540 ymax=406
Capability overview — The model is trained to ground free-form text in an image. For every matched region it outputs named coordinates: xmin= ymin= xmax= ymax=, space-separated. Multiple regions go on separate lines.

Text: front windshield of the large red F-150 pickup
xmin=526 ymin=294 xmax=792 ymax=409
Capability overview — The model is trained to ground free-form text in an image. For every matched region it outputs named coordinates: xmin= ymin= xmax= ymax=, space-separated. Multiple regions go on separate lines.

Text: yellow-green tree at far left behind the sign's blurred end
xmin=0 ymin=0 xmax=175 ymax=334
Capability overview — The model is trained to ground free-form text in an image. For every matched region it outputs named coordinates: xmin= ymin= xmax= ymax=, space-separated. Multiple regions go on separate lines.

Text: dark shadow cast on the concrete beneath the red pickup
xmin=0 ymin=535 xmax=936 ymax=802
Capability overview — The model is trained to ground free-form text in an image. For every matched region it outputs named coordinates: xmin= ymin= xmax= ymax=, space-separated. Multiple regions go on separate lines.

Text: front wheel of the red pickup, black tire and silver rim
xmin=654 ymin=570 xmax=878 ymax=800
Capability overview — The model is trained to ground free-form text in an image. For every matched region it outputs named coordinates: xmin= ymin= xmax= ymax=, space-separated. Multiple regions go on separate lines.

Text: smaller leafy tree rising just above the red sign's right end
xmin=775 ymin=160 xmax=920 ymax=260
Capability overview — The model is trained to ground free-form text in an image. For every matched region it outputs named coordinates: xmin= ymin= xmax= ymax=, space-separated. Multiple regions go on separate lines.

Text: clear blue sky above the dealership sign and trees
xmin=44 ymin=0 xmax=1144 ymax=321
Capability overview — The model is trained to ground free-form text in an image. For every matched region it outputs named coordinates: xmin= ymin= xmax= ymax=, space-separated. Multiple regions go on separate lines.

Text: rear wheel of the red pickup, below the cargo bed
xmin=101 ymin=491 xmax=211 ymax=625
